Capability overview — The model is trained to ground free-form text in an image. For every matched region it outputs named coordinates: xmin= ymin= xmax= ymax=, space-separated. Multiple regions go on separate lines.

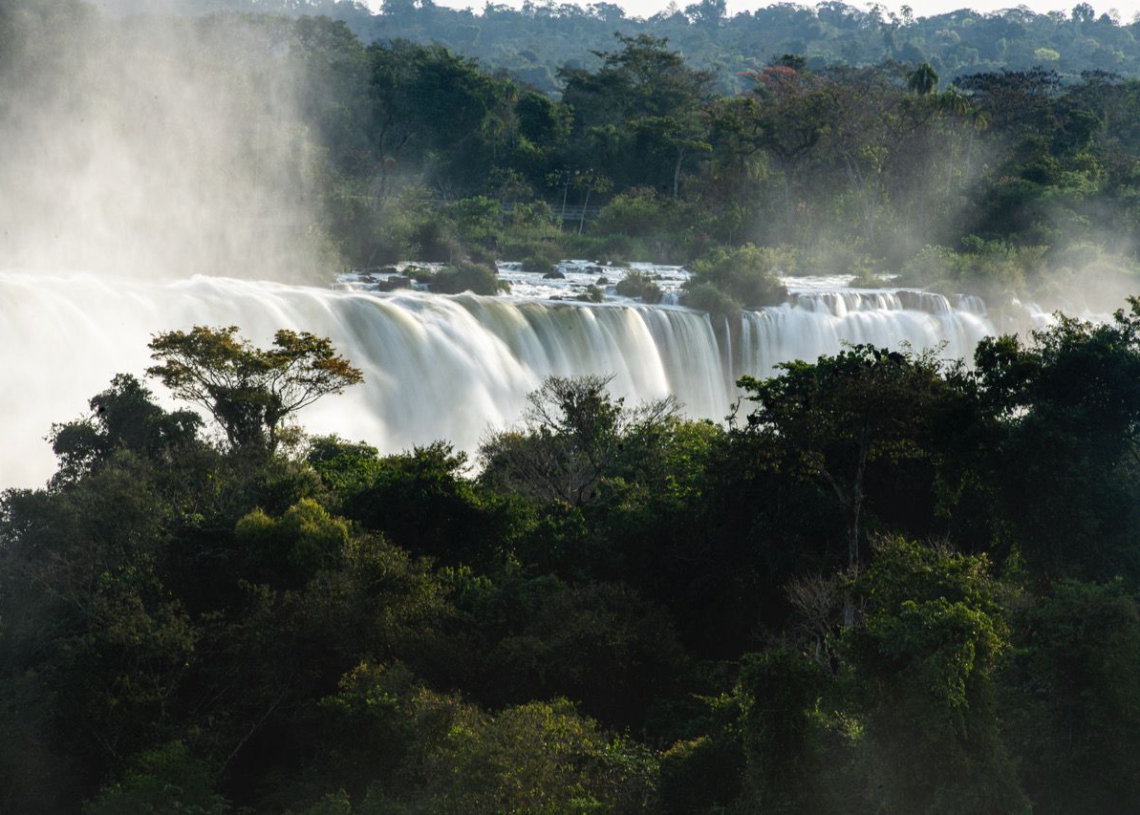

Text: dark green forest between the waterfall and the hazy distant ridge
xmin=300 ymin=24 xmax=1134 ymax=264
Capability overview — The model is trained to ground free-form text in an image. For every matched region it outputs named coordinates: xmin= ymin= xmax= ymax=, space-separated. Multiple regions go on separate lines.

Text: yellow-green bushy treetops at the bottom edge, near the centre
xmin=325 ymin=665 xmax=656 ymax=813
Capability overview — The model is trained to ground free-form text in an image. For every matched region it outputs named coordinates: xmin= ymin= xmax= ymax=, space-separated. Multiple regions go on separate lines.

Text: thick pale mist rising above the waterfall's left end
xmin=0 ymin=3 xmax=327 ymax=279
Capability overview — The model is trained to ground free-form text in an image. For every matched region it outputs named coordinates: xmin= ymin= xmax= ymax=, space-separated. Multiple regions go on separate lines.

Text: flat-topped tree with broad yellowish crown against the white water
xmin=147 ymin=326 xmax=364 ymax=453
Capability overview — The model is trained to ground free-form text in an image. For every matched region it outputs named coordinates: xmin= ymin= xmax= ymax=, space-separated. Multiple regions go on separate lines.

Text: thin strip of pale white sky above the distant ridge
xmin=367 ymin=0 xmax=1140 ymax=23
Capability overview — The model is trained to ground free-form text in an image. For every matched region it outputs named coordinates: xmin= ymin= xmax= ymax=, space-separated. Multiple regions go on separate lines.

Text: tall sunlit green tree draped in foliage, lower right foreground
xmin=845 ymin=539 xmax=1028 ymax=813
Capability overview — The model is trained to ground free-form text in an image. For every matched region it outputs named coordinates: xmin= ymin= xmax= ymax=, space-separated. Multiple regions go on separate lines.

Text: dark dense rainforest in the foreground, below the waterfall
xmin=0 ymin=310 xmax=1140 ymax=815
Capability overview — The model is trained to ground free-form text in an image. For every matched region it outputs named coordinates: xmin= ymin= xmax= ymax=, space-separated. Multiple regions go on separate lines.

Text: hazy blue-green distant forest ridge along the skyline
xmin=92 ymin=0 xmax=1140 ymax=93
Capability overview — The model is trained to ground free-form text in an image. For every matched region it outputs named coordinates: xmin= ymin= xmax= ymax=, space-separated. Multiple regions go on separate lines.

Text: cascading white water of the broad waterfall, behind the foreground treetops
xmin=0 ymin=272 xmax=992 ymax=488
